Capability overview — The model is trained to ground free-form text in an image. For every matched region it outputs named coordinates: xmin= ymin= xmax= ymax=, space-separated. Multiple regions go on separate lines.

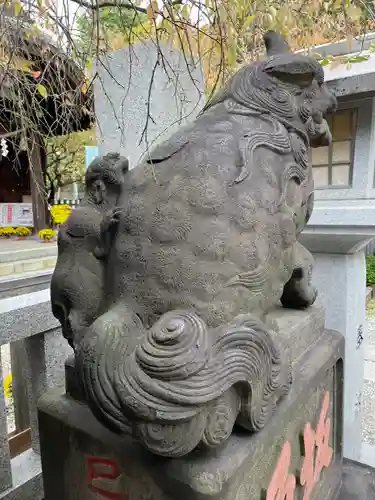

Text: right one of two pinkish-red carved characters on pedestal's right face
xmin=300 ymin=392 xmax=333 ymax=500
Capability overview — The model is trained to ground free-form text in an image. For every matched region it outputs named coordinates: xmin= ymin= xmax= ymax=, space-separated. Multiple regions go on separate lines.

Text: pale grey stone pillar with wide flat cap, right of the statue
xmin=301 ymin=202 xmax=375 ymax=461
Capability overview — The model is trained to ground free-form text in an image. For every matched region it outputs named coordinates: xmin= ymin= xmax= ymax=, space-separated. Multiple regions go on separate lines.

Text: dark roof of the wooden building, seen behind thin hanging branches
xmin=0 ymin=7 xmax=93 ymax=135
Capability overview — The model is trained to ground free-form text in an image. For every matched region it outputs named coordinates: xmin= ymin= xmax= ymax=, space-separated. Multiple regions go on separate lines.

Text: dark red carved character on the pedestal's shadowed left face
xmin=87 ymin=457 xmax=128 ymax=500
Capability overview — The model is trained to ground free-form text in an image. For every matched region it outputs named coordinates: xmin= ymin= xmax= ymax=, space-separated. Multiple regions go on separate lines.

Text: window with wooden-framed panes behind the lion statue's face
xmin=310 ymin=110 xmax=356 ymax=188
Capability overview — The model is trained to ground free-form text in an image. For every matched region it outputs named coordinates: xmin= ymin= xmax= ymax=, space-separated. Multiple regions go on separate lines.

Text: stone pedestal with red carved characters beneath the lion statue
xmin=39 ymin=306 xmax=346 ymax=500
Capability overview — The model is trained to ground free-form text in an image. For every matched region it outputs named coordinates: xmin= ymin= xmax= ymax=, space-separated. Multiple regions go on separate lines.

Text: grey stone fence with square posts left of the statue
xmin=0 ymin=285 xmax=72 ymax=500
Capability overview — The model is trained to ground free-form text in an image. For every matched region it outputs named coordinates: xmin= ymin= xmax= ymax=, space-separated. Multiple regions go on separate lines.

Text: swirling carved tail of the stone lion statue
xmin=78 ymin=311 xmax=290 ymax=457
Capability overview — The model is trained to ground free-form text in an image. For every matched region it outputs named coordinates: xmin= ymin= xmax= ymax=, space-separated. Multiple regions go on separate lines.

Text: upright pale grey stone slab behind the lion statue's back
xmin=94 ymin=41 xmax=204 ymax=168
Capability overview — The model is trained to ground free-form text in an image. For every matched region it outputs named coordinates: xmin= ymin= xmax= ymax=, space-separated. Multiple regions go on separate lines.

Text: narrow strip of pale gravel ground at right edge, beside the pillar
xmin=362 ymin=300 xmax=375 ymax=445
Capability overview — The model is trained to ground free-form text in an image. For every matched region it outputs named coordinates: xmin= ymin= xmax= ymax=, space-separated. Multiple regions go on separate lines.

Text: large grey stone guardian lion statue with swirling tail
xmin=52 ymin=32 xmax=336 ymax=457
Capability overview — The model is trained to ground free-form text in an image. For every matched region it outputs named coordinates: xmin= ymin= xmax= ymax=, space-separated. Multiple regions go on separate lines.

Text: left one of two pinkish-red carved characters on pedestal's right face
xmin=266 ymin=441 xmax=296 ymax=500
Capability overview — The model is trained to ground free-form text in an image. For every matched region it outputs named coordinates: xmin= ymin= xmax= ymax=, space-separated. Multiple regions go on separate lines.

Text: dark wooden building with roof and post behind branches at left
xmin=0 ymin=8 xmax=93 ymax=230
